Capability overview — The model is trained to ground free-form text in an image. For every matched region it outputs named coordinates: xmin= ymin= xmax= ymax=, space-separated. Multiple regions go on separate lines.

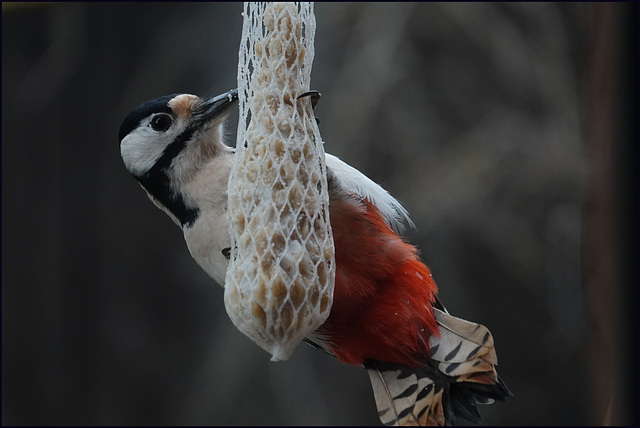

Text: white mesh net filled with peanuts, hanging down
xmin=224 ymin=3 xmax=335 ymax=361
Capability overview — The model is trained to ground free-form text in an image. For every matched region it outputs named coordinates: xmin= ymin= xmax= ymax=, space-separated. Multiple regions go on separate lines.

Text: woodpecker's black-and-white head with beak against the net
xmin=118 ymin=89 xmax=238 ymax=225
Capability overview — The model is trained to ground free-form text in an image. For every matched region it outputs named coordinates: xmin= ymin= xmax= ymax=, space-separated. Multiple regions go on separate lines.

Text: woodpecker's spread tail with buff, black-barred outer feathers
xmin=365 ymin=308 xmax=512 ymax=425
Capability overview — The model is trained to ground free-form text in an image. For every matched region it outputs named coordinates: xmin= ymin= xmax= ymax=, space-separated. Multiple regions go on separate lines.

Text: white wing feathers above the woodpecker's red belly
xmin=326 ymin=153 xmax=415 ymax=234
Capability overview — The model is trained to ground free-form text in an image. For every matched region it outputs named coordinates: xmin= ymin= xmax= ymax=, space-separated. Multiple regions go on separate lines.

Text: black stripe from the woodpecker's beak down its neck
xmin=136 ymin=128 xmax=200 ymax=227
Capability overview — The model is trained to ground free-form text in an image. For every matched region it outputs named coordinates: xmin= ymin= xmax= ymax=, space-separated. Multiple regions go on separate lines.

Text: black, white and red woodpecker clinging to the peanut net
xmin=119 ymin=90 xmax=512 ymax=425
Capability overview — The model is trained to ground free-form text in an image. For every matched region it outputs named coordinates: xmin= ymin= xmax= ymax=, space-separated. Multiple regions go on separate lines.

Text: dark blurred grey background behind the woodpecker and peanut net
xmin=2 ymin=2 xmax=638 ymax=425
